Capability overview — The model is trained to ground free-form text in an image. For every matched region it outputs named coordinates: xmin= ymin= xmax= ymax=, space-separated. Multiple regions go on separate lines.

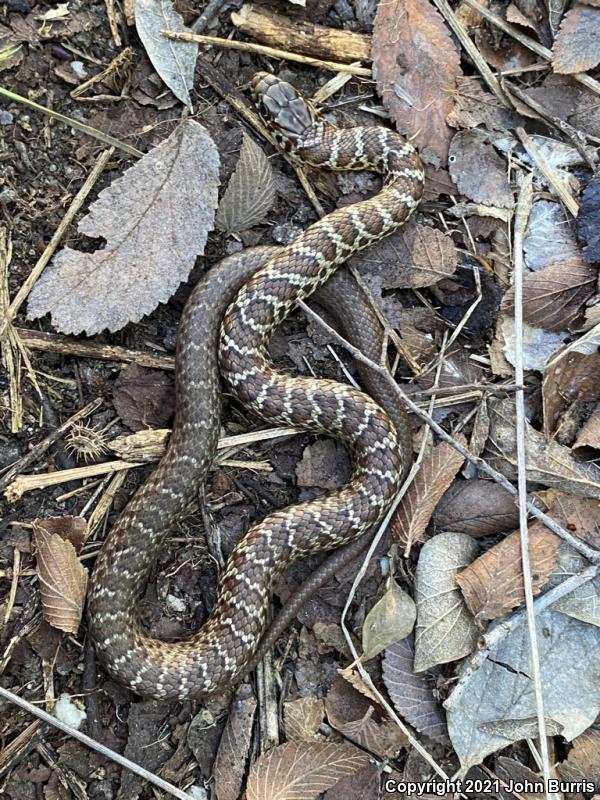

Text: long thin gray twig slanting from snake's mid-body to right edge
xmin=297 ymin=301 xmax=600 ymax=564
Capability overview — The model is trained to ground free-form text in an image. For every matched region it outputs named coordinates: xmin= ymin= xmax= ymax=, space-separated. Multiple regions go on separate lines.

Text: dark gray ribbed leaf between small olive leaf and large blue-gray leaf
xmin=383 ymin=636 xmax=448 ymax=742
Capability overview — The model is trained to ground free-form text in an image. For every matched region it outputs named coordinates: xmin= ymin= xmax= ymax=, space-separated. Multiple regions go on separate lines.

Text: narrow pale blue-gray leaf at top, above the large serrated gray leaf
xmin=135 ymin=0 xmax=198 ymax=111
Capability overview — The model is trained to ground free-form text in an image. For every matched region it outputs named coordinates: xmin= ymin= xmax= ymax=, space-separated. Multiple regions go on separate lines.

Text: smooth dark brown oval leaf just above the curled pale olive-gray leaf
xmin=433 ymin=478 xmax=519 ymax=536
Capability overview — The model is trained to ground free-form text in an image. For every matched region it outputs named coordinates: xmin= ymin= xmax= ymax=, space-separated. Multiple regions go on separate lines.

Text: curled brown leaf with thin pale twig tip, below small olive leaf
xmin=325 ymin=678 xmax=406 ymax=756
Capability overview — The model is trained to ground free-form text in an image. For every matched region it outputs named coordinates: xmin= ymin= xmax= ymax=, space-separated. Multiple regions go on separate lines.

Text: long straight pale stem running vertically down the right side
xmin=513 ymin=174 xmax=550 ymax=800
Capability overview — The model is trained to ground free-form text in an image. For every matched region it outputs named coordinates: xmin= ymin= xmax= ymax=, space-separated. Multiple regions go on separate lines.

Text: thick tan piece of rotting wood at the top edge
xmin=231 ymin=3 xmax=371 ymax=64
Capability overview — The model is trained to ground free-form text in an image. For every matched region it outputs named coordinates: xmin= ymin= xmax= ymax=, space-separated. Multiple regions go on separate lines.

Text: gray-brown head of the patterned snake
xmin=251 ymin=72 xmax=318 ymax=153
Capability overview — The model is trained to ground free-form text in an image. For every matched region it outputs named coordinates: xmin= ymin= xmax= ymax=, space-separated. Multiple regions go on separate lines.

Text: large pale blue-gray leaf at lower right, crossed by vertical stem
xmin=445 ymin=610 xmax=600 ymax=772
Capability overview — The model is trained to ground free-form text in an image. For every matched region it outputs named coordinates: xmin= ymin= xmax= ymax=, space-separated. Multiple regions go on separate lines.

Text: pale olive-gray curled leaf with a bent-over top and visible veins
xmin=414 ymin=533 xmax=479 ymax=672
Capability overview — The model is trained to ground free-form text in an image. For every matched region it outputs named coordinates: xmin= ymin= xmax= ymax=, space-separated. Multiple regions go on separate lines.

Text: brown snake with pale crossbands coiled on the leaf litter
xmin=87 ymin=72 xmax=424 ymax=699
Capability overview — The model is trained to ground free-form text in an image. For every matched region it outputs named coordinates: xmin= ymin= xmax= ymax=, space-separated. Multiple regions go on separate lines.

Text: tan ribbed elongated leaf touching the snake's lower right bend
xmin=390 ymin=435 xmax=467 ymax=549
